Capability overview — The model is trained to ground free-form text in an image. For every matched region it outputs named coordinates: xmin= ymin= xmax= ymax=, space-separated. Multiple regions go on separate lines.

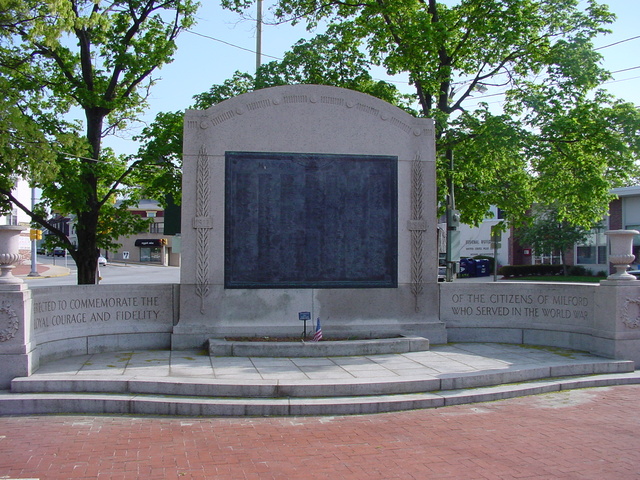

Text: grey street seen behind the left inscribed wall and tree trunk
xmin=23 ymin=255 xmax=180 ymax=288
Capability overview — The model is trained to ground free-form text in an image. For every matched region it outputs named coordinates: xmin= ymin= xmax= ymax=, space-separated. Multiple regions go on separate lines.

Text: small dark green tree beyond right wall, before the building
xmin=517 ymin=206 xmax=590 ymax=275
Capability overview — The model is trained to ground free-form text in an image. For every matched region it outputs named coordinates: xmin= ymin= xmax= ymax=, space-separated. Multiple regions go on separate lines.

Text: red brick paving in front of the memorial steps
xmin=0 ymin=386 xmax=640 ymax=480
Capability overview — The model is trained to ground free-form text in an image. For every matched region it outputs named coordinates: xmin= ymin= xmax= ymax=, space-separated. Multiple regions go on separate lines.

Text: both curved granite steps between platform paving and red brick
xmin=0 ymin=361 xmax=640 ymax=416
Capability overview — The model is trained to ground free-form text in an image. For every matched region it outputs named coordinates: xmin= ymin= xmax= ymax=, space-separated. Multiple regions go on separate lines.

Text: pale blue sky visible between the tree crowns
xmin=105 ymin=0 xmax=640 ymax=154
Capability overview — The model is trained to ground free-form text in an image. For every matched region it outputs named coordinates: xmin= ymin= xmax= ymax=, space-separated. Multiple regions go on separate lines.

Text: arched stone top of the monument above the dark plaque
xmin=185 ymin=85 xmax=435 ymax=160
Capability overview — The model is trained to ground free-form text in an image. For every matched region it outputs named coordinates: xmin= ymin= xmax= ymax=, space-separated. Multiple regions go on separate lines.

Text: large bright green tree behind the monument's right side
xmin=223 ymin=0 xmax=640 ymax=226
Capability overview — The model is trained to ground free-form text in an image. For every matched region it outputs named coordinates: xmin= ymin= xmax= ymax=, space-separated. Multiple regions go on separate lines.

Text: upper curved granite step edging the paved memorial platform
xmin=11 ymin=360 xmax=634 ymax=398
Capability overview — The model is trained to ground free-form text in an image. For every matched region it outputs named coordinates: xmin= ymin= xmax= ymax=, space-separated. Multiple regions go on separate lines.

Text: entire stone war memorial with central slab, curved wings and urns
xmin=0 ymin=85 xmax=640 ymax=414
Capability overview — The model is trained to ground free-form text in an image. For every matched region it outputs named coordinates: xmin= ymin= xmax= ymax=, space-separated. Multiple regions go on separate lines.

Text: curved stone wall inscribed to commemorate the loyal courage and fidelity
xmin=31 ymin=285 xmax=179 ymax=362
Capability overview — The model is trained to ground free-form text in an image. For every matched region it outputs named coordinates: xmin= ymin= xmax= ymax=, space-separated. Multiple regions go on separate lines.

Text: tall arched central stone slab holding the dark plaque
xmin=172 ymin=85 xmax=446 ymax=349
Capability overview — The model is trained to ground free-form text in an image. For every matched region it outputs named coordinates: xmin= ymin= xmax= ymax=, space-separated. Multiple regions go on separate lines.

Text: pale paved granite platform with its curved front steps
xmin=0 ymin=343 xmax=640 ymax=416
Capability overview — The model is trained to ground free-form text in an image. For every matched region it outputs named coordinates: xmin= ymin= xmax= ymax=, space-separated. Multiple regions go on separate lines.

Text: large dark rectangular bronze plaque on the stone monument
xmin=225 ymin=152 xmax=398 ymax=288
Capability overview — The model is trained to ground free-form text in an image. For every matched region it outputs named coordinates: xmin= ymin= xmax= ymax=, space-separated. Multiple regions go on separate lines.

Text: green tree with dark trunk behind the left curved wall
xmin=0 ymin=0 xmax=197 ymax=284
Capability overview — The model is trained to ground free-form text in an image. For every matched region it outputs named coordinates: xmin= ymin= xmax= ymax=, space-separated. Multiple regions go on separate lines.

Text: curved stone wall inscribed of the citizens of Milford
xmin=440 ymin=281 xmax=640 ymax=362
